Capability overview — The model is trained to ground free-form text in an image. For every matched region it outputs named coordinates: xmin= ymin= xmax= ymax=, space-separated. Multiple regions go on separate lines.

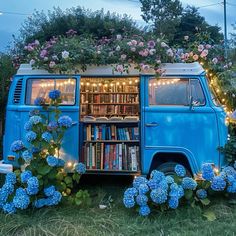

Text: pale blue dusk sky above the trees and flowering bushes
xmin=0 ymin=0 xmax=236 ymax=51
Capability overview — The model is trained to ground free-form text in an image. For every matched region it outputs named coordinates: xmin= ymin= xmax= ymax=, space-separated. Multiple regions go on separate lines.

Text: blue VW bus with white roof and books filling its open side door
xmin=3 ymin=63 xmax=227 ymax=175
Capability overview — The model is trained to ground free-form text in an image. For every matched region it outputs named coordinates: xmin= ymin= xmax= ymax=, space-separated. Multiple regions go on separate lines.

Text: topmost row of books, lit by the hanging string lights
xmin=80 ymin=84 xmax=139 ymax=93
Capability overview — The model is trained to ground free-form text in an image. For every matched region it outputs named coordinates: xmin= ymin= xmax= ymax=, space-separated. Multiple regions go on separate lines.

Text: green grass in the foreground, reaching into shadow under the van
xmin=0 ymin=177 xmax=236 ymax=236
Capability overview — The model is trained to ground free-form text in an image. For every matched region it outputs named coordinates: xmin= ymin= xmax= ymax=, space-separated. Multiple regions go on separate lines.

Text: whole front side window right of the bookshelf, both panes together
xmin=149 ymin=78 xmax=205 ymax=106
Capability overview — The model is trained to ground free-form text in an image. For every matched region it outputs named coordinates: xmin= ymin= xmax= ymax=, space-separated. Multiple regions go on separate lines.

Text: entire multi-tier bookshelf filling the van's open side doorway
xmin=80 ymin=77 xmax=140 ymax=174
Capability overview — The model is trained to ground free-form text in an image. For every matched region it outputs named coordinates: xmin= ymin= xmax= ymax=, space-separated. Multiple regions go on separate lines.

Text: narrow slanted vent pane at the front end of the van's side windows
xmin=190 ymin=79 xmax=205 ymax=106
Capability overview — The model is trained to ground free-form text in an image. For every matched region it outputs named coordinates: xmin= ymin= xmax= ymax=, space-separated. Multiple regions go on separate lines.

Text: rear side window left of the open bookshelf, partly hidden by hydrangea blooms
xmin=26 ymin=78 xmax=76 ymax=105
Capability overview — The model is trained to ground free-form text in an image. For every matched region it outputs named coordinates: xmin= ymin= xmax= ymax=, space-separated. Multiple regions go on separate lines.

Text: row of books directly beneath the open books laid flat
xmin=84 ymin=124 xmax=139 ymax=141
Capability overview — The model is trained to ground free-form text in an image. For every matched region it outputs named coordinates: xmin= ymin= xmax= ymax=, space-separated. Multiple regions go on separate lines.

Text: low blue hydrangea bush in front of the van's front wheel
xmin=123 ymin=163 xmax=236 ymax=216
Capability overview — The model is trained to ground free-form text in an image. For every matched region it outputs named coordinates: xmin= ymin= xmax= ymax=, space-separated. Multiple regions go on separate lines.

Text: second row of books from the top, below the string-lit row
xmin=80 ymin=94 xmax=139 ymax=103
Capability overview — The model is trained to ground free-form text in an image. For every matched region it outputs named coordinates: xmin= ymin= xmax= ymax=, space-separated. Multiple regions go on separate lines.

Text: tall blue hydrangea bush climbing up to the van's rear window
xmin=0 ymin=90 xmax=89 ymax=214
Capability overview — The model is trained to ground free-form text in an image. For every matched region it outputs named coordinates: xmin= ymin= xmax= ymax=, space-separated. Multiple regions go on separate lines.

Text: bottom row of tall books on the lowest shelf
xmin=82 ymin=143 xmax=140 ymax=171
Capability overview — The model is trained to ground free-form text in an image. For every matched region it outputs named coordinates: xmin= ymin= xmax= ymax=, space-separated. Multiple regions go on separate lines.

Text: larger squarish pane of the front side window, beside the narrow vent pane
xmin=149 ymin=78 xmax=190 ymax=106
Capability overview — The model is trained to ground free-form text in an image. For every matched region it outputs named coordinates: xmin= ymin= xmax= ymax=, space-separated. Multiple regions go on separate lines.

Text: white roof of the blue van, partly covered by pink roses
xmin=17 ymin=62 xmax=204 ymax=76
